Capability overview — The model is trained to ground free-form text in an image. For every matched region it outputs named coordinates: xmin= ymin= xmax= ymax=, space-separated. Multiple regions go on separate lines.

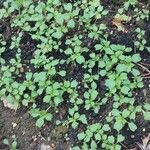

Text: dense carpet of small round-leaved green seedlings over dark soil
xmin=0 ymin=0 xmax=150 ymax=150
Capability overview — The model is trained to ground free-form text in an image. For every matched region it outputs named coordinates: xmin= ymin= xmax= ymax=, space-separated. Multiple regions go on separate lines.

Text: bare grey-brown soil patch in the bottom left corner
xmin=0 ymin=104 xmax=70 ymax=150
